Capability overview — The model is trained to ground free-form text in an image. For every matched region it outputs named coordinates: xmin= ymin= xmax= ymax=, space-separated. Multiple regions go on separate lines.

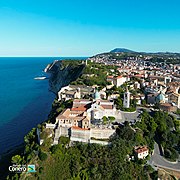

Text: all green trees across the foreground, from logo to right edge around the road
xmin=6 ymin=105 xmax=180 ymax=179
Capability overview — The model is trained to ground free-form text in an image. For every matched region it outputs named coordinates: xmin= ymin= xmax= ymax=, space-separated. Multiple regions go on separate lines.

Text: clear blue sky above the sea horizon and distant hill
xmin=0 ymin=0 xmax=180 ymax=56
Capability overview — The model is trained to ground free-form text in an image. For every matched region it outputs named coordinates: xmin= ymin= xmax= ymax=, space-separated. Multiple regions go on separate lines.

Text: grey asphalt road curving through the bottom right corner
xmin=149 ymin=142 xmax=180 ymax=172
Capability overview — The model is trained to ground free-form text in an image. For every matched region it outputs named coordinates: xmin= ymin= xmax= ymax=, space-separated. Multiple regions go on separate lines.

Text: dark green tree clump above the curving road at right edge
xmin=136 ymin=111 xmax=180 ymax=161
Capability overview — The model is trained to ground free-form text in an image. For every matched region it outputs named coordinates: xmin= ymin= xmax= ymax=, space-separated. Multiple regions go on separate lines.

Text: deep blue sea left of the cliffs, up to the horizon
xmin=0 ymin=57 xmax=86 ymax=154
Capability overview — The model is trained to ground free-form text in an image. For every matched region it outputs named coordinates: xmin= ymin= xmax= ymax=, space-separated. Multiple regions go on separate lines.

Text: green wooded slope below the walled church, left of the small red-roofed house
xmin=7 ymin=124 xmax=156 ymax=180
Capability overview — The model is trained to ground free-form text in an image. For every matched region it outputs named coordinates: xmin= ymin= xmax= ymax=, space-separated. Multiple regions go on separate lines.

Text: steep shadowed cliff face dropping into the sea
xmin=47 ymin=61 xmax=85 ymax=94
